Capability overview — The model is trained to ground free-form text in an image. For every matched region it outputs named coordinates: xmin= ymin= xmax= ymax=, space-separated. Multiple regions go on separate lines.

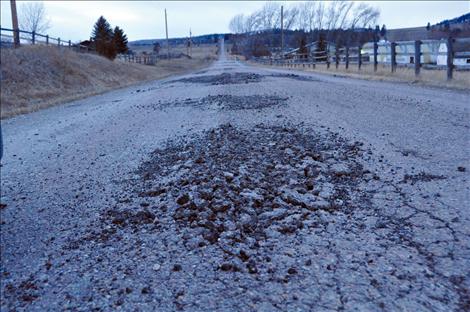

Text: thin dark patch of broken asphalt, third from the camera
xmin=167 ymin=73 xmax=263 ymax=85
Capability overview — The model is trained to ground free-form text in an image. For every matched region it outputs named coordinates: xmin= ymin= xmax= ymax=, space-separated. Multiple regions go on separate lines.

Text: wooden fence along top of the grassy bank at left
xmin=0 ymin=27 xmax=93 ymax=51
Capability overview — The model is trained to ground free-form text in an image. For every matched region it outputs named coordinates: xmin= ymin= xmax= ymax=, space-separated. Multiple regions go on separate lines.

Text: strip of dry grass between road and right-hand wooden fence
xmin=249 ymin=62 xmax=470 ymax=90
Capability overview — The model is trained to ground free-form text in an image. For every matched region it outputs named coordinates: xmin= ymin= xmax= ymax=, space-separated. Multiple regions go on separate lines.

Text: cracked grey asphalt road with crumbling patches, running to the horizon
xmin=0 ymin=52 xmax=470 ymax=311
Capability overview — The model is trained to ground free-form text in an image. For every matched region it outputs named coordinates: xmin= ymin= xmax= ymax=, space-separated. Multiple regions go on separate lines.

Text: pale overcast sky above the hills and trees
xmin=1 ymin=0 xmax=470 ymax=41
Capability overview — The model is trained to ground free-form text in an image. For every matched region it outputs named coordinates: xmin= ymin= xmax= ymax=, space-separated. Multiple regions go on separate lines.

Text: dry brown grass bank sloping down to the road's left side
xmin=0 ymin=46 xmax=215 ymax=119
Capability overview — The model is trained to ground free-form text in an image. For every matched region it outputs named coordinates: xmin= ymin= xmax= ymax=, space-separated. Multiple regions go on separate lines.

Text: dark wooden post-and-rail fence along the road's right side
xmin=255 ymin=38 xmax=470 ymax=80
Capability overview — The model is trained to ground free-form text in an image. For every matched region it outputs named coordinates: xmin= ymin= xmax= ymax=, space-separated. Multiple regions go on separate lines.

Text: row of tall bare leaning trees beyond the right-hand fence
xmin=229 ymin=0 xmax=386 ymax=57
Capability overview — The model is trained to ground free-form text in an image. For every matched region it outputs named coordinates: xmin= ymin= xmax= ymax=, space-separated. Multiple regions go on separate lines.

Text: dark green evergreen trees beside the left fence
xmin=91 ymin=16 xmax=129 ymax=60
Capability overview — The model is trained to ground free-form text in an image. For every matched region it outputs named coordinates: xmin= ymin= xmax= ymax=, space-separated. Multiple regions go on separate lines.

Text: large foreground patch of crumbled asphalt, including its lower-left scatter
xmin=81 ymin=124 xmax=368 ymax=275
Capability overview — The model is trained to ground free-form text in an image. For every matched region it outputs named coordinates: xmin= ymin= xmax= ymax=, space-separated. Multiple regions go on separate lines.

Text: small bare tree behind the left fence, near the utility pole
xmin=19 ymin=2 xmax=50 ymax=33
